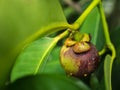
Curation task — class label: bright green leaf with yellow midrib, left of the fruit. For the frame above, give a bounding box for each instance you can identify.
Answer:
[11,37,57,81]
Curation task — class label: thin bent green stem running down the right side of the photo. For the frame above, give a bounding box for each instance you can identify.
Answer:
[99,2,116,90]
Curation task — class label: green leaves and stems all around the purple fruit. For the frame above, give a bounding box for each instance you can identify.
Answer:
[0,0,120,90]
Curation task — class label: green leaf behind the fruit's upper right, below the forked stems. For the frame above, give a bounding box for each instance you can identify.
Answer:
[80,7,104,50]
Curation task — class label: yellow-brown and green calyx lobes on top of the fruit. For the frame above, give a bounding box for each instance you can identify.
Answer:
[65,31,90,53]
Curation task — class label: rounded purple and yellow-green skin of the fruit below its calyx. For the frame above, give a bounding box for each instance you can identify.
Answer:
[60,43,99,77]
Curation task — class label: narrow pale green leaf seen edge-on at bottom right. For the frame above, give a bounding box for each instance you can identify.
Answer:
[104,55,112,90]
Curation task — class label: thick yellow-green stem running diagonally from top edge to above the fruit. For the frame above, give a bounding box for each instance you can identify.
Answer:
[73,0,101,30]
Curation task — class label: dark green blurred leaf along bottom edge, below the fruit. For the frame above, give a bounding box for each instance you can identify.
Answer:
[8,74,90,90]
